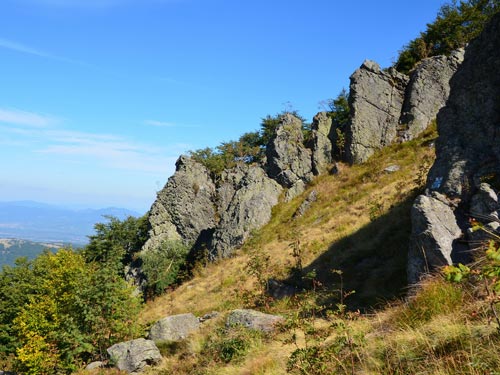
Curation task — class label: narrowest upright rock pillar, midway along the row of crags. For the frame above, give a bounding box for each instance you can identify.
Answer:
[311,112,336,175]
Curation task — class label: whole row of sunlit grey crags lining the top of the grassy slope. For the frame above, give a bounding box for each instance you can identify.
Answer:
[143,42,462,260]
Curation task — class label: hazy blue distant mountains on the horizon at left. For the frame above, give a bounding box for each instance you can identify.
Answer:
[0,201,140,245]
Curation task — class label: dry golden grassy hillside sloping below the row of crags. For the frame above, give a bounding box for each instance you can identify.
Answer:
[87,125,500,375]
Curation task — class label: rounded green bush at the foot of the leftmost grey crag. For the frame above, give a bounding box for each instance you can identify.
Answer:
[140,240,189,295]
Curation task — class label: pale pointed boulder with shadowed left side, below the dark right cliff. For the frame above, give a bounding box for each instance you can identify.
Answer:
[408,195,462,284]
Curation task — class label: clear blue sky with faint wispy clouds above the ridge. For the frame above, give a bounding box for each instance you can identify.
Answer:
[0,0,442,213]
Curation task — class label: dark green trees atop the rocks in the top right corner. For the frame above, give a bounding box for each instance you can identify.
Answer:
[395,0,500,74]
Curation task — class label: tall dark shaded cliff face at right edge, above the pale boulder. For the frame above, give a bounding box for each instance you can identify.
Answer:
[428,15,500,197]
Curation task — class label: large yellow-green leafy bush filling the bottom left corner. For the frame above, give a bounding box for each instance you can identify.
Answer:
[0,249,140,374]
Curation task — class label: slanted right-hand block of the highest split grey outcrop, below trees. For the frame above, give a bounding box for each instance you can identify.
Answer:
[398,49,464,141]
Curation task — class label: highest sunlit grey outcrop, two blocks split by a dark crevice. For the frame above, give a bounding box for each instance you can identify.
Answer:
[346,50,464,163]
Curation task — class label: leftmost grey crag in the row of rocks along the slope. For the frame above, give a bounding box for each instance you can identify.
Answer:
[144,156,216,250]
